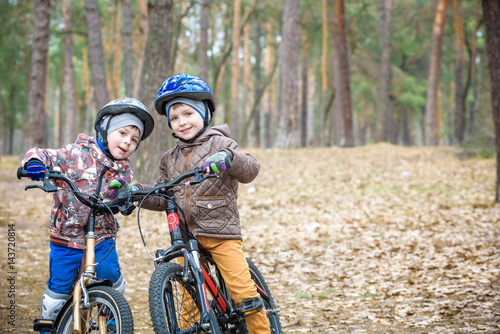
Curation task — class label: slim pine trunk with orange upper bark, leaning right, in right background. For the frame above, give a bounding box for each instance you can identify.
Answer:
[425,0,448,146]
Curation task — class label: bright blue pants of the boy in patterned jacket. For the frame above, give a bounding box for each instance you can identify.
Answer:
[47,239,121,294]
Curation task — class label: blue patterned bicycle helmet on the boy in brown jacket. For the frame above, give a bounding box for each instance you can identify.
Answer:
[155,73,215,127]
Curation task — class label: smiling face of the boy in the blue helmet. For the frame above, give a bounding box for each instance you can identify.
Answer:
[169,103,204,140]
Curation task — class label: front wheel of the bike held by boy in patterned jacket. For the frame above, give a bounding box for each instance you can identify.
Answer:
[56,286,134,334]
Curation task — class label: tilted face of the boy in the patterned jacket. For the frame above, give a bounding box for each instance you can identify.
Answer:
[107,125,141,160]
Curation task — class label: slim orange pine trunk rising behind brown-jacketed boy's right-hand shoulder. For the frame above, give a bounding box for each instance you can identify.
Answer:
[227,0,241,138]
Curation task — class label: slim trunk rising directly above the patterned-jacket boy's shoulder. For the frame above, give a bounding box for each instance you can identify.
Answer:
[63,0,77,142]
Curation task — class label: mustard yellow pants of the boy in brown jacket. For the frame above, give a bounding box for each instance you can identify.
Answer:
[178,237,270,334]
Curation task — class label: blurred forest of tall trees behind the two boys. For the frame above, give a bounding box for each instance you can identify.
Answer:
[0,0,498,175]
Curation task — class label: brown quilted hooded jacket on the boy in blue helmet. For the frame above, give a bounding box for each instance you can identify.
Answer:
[137,125,260,240]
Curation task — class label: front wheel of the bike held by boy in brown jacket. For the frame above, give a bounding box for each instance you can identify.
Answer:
[149,263,220,334]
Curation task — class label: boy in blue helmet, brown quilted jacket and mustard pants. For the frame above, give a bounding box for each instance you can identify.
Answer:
[119,74,269,334]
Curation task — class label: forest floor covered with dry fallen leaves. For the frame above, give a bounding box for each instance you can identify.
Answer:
[0,144,500,334]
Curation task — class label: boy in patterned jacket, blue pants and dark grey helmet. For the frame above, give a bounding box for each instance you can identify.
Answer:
[21,97,154,328]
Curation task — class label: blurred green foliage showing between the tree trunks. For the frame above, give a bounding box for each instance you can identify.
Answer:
[0,0,491,154]
